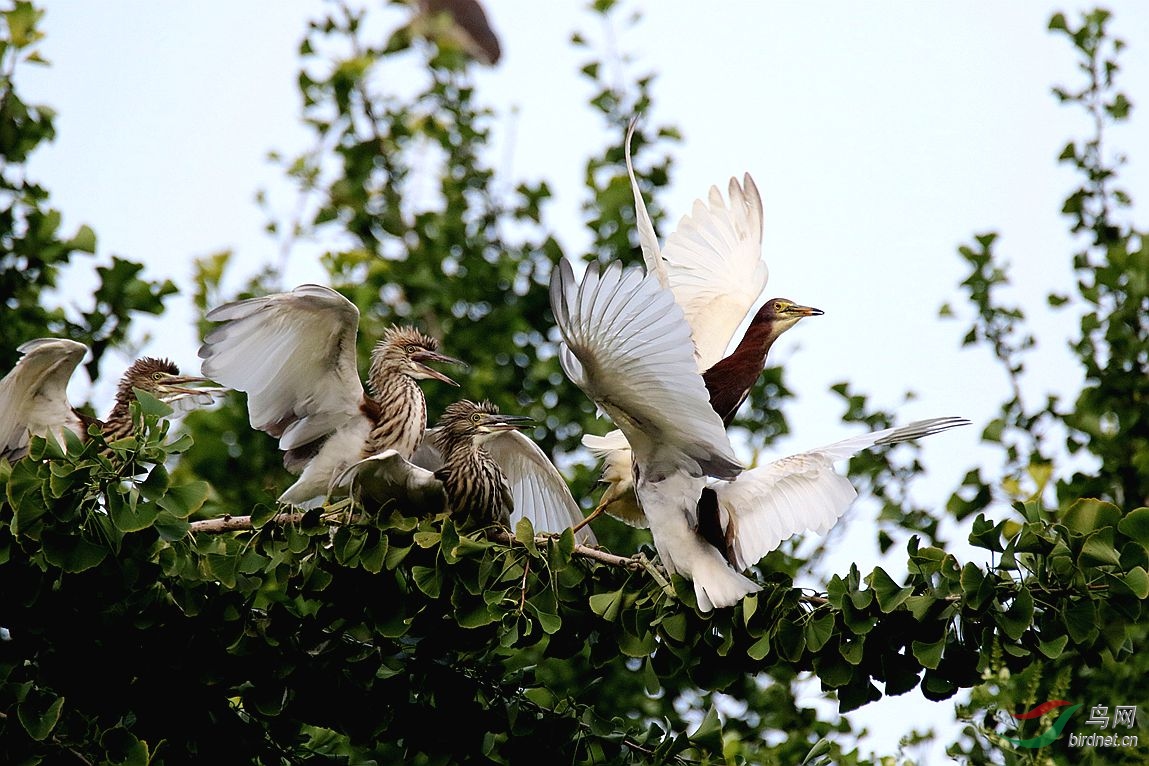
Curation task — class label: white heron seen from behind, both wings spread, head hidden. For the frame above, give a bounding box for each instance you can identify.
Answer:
[550,260,969,611]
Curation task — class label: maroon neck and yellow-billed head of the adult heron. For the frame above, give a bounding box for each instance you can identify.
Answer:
[702,297,823,426]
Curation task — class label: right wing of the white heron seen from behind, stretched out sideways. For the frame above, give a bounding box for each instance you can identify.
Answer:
[711,418,970,570]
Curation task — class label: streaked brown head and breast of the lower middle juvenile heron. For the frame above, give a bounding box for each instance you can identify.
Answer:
[433,399,531,527]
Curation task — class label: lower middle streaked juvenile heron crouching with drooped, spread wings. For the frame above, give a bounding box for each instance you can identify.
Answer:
[337,401,597,546]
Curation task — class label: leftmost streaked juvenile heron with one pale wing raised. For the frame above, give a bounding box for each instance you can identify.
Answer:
[0,338,225,461]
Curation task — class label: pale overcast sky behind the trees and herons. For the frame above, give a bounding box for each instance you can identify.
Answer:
[20,0,1149,763]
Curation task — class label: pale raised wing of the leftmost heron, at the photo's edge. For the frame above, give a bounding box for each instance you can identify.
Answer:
[0,338,87,458]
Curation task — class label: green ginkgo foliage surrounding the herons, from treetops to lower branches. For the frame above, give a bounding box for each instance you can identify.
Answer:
[0,2,1149,765]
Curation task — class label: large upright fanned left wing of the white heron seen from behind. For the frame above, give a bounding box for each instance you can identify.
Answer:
[550,260,742,478]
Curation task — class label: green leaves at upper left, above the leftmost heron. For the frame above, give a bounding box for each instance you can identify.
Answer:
[0,0,176,380]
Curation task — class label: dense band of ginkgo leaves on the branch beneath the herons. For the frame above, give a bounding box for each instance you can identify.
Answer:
[0,415,1149,764]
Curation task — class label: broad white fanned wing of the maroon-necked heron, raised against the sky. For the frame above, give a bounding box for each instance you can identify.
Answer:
[662,173,769,370]
